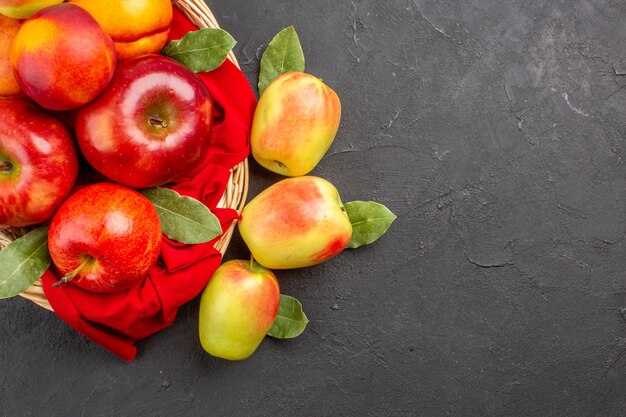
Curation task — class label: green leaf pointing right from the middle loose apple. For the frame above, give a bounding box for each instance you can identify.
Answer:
[344,201,396,248]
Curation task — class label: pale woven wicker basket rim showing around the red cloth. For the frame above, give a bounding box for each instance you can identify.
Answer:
[0,0,249,311]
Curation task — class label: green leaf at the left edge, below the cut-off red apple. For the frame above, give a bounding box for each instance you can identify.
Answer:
[0,227,51,298]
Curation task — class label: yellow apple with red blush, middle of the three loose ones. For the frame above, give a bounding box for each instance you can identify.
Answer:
[239,176,352,269]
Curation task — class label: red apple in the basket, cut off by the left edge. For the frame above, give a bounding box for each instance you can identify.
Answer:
[0,99,78,229]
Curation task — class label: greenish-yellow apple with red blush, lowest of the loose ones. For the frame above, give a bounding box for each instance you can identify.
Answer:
[199,260,280,360]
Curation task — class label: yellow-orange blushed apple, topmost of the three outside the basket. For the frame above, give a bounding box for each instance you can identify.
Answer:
[250,72,341,177]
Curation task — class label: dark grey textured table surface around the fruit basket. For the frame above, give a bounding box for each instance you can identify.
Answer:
[0,0,626,417]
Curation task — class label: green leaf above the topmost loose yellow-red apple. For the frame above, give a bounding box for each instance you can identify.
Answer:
[259,26,304,96]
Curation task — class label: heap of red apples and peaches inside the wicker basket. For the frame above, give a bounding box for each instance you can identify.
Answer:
[0,0,218,292]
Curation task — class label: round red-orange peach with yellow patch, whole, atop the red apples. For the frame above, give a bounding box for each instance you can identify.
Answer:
[10,3,116,110]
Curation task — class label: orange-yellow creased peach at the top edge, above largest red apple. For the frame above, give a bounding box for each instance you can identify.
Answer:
[70,0,173,60]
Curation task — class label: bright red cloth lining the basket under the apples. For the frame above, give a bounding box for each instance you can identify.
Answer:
[42,8,256,362]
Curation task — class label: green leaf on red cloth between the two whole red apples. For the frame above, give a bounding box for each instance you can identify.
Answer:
[141,187,222,244]
